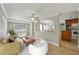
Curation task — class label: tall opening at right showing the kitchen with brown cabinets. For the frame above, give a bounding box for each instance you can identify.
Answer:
[59,11,79,50]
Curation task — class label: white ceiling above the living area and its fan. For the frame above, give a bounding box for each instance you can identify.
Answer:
[3,3,79,19]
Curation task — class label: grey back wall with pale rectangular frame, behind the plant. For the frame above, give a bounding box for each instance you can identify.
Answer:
[7,21,30,35]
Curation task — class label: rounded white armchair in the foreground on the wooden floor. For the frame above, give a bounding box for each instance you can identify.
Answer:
[29,39,48,55]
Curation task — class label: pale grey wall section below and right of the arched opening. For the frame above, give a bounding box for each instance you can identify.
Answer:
[35,16,60,45]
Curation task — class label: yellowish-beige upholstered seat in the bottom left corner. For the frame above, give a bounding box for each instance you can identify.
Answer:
[0,42,21,55]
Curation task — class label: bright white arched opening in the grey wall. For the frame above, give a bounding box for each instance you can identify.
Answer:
[36,19,55,31]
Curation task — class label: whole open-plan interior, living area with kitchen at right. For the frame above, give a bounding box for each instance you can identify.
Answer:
[0,3,79,55]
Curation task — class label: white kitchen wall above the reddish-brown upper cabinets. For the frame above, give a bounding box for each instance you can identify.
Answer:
[59,11,78,23]
